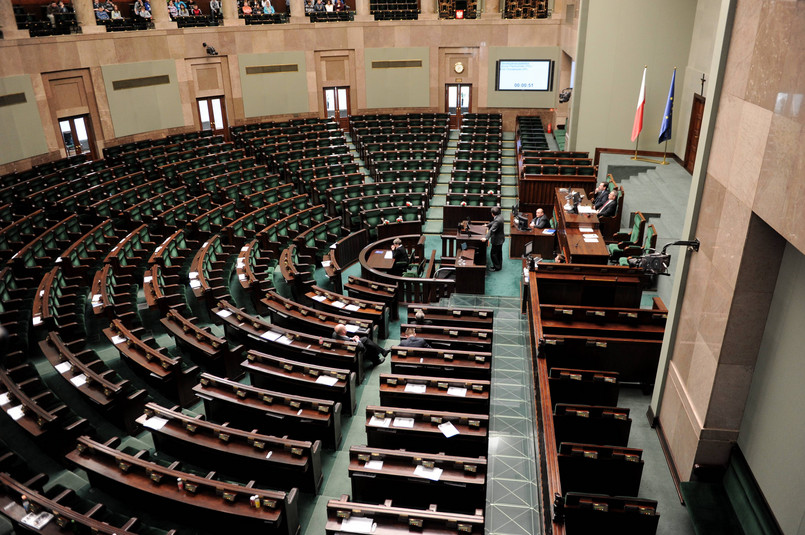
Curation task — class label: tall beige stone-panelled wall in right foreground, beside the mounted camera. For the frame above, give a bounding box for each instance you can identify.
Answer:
[659,0,805,480]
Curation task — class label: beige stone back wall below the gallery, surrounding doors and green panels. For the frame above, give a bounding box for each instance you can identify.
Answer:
[0,17,561,173]
